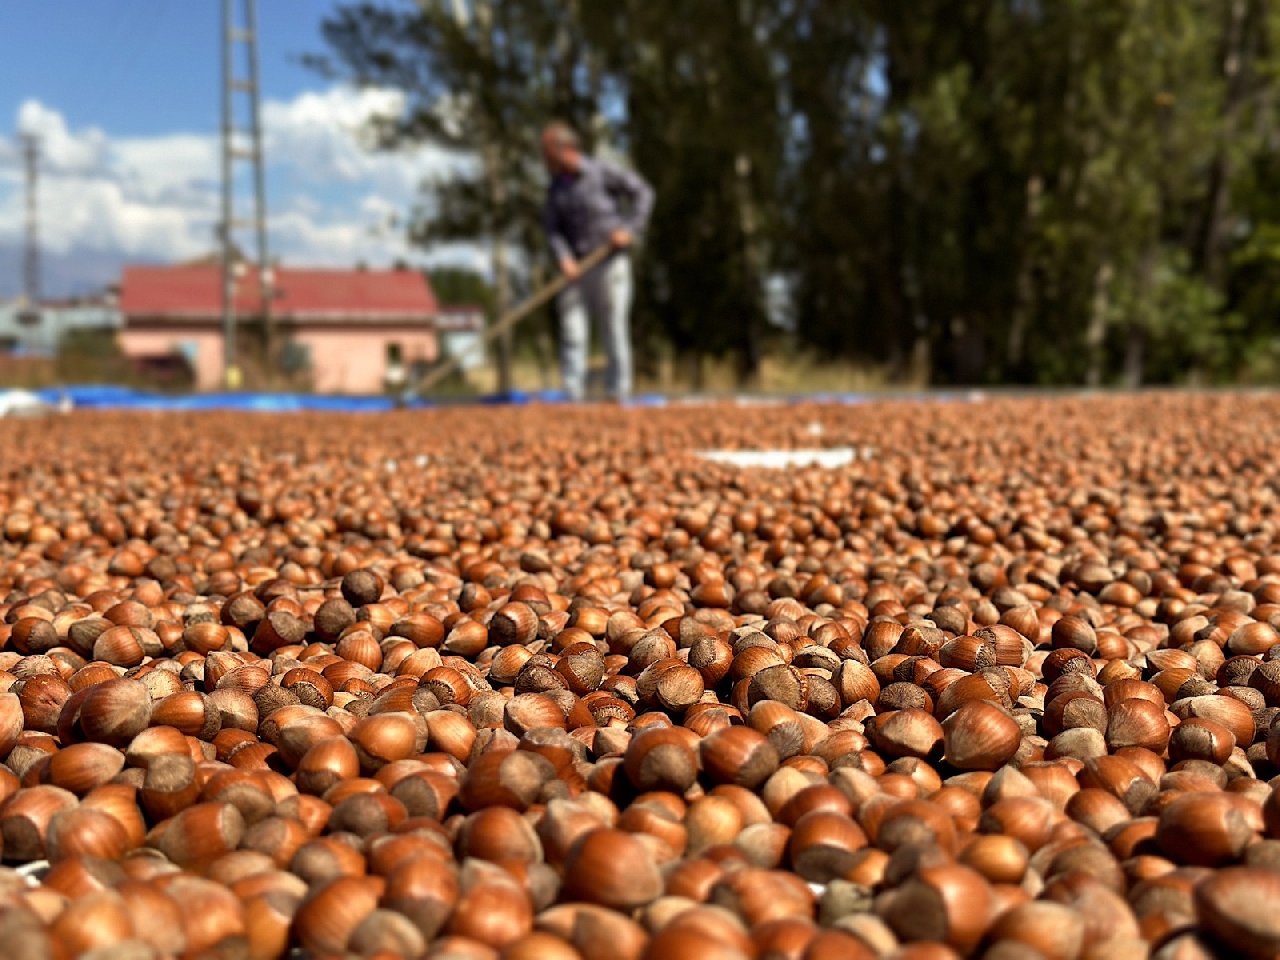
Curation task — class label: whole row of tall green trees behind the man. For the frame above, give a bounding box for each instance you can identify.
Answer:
[315,0,1280,385]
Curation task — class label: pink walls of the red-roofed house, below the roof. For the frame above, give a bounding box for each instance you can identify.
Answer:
[119,325,439,393]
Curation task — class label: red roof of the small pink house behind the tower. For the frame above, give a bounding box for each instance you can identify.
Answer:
[120,264,439,321]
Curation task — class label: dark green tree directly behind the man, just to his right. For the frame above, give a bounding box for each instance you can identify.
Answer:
[589,0,783,384]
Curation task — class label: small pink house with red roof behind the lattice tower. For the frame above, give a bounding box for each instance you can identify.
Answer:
[120,261,483,393]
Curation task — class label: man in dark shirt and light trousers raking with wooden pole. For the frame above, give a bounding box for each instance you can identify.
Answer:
[543,123,653,401]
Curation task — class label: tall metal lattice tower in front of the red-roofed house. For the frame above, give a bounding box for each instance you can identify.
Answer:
[220,0,274,388]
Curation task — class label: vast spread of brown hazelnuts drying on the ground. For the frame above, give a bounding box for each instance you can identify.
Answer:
[0,393,1280,960]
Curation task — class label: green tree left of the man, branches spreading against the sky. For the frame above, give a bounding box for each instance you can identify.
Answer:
[317,0,595,389]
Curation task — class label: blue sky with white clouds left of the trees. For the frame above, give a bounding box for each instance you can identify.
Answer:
[0,0,475,297]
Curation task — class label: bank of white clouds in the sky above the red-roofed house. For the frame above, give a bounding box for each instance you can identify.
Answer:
[0,87,481,288]
